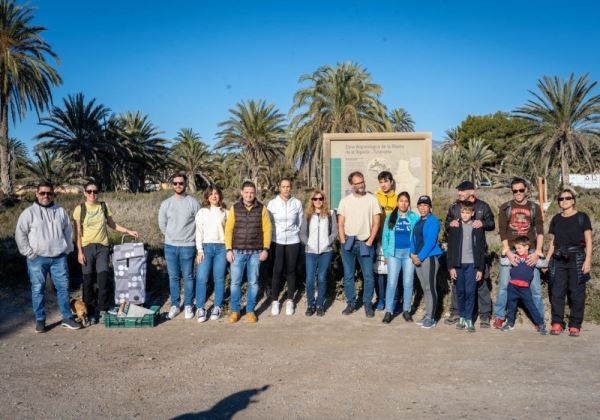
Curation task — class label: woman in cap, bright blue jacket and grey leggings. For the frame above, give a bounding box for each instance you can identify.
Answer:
[410,195,442,328]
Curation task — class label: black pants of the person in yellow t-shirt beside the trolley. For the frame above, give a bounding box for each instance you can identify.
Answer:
[82,244,111,313]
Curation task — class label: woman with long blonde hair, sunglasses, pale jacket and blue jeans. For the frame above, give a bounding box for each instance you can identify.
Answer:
[300,190,338,316]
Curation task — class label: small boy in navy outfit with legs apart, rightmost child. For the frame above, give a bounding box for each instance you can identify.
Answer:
[501,236,547,335]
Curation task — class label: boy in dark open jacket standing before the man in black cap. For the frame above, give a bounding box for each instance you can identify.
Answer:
[448,201,485,332]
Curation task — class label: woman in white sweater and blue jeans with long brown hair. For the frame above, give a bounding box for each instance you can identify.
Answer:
[196,185,227,322]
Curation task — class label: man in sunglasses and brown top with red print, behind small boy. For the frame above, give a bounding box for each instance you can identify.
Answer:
[494,178,544,329]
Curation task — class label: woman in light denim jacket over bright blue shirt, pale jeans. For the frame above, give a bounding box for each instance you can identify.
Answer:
[381,191,420,324]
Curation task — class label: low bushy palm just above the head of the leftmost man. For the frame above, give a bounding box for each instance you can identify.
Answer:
[25,150,81,187]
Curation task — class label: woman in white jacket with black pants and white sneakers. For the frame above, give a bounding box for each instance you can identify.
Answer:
[267,178,304,315]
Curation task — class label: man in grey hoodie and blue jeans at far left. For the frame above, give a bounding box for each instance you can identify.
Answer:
[15,182,81,333]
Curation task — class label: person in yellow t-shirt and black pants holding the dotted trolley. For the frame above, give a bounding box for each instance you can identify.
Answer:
[73,181,138,324]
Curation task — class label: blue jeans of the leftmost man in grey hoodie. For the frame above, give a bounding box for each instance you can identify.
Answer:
[27,254,73,321]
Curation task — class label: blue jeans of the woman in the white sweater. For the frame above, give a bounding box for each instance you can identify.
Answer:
[196,244,227,308]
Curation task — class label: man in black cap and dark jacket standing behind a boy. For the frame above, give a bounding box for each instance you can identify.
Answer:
[444,181,496,328]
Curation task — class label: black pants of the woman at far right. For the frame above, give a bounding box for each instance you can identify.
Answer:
[550,261,587,328]
